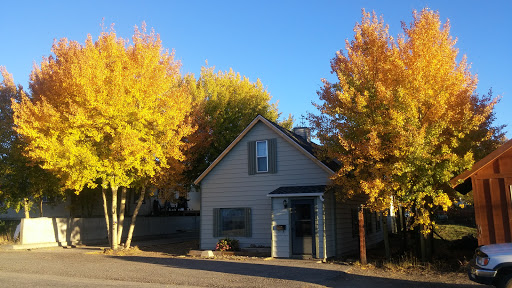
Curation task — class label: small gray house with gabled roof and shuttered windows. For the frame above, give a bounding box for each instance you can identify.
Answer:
[195,116,382,259]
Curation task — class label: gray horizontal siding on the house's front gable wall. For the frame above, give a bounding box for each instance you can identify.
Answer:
[200,122,329,249]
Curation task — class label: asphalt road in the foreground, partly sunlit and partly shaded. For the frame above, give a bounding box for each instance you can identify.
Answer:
[0,244,485,288]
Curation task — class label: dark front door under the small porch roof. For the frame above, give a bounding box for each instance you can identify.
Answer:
[291,199,315,256]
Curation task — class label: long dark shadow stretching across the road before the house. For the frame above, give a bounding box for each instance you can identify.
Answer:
[113,256,485,288]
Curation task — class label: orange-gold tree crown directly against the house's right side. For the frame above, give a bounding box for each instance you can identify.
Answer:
[310,11,405,214]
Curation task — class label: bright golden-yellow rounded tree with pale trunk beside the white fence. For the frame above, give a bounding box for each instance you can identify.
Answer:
[13,24,194,249]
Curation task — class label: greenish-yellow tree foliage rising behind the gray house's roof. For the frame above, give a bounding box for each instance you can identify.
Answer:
[177,67,293,183]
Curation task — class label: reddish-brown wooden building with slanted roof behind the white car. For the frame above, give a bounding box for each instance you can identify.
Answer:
[451,140,512,245]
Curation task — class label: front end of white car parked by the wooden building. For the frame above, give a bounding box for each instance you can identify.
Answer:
[468,243,512,288]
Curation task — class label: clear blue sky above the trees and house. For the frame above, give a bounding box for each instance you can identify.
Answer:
[0,0,512,138]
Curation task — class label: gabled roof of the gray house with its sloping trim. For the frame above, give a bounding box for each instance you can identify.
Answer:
[194,115,334,185]
